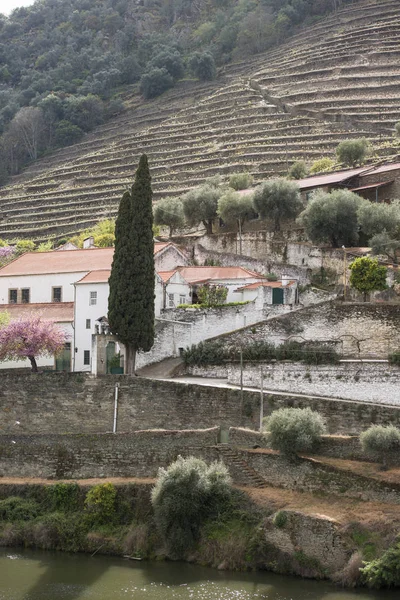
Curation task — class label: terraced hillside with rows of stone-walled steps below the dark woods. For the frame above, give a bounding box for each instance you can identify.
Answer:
[0,0,400,239]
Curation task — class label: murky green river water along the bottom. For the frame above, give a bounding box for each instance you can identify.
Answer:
[0,548,400,600]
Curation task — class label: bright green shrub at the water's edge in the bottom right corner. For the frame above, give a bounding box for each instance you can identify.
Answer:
[360,542,400,589]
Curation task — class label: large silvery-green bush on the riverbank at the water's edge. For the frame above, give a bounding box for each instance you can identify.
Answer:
[151,456,232,558]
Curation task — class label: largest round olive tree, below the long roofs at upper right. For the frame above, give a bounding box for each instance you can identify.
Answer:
[299,190,362,248]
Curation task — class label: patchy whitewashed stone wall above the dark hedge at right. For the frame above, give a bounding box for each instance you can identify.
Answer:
[209,301,400,358]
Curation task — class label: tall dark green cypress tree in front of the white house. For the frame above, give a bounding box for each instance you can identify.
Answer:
[108,155,155,375]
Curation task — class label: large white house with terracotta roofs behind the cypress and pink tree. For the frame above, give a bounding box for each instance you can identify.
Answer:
[0,242,188,371]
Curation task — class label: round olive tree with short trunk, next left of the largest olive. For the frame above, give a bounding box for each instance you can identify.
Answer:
[254,178,302,231]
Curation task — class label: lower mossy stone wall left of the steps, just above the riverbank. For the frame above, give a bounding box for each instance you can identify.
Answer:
[0,427,219,479]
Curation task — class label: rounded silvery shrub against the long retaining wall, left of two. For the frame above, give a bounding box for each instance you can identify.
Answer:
[264,408,325,456]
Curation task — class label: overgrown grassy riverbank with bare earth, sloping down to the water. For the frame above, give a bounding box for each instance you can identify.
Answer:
[0,478,400,586]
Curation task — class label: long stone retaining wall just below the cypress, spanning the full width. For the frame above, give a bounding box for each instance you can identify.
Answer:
[0,373,400,436]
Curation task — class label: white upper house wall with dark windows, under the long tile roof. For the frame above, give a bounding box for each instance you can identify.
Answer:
[0,271,87,304]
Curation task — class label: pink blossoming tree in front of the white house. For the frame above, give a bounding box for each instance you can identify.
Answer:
[0,315,68,373]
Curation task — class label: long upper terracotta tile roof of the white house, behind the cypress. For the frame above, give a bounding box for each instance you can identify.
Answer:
[0,242,174,277]
